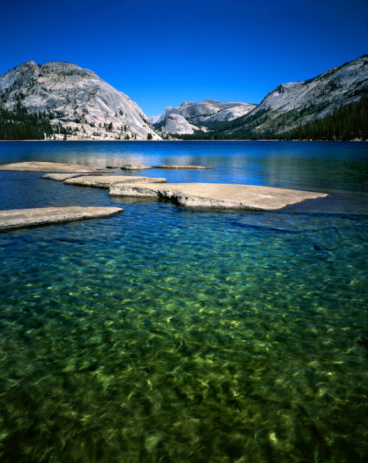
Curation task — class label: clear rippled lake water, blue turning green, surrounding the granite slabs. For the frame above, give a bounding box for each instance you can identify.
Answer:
[0,142,368,463]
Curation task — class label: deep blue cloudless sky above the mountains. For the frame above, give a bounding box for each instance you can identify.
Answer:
[0,0,368,116]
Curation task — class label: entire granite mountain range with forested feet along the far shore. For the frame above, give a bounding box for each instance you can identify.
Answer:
[0,55,368,140]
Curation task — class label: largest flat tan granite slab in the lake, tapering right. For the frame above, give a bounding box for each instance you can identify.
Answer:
[110,183,327,211]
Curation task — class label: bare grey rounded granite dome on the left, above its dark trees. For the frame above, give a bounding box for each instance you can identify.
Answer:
[0,61,160,140]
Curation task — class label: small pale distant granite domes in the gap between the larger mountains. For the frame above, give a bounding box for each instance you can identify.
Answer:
[156,99,256,134]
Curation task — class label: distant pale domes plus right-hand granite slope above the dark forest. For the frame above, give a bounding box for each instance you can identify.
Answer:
[154,55,368,138]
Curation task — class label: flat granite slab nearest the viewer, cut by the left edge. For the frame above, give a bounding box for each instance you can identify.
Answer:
[0,206,123,230]
